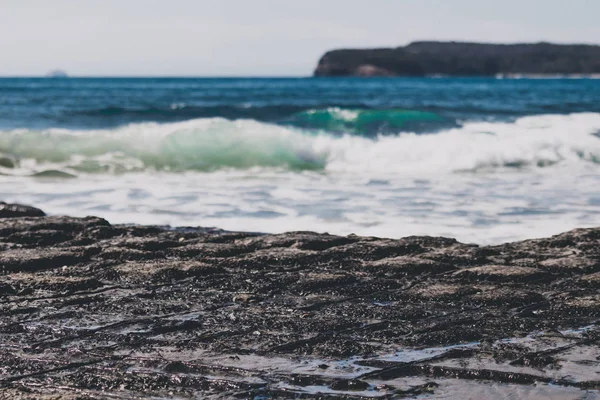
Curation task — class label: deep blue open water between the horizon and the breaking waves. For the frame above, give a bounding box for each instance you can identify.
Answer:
[0,78,600,130]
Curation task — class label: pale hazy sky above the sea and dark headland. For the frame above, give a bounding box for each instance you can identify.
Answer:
[0,0,600,76]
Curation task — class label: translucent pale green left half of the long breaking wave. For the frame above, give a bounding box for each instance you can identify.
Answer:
[0,118,327,173]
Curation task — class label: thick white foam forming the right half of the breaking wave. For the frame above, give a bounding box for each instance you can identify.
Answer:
[315,113,600,176]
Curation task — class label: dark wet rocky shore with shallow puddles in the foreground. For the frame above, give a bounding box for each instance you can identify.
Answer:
[0,204,600,399]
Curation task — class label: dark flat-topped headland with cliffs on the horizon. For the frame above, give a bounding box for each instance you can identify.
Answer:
[314,42,600,76]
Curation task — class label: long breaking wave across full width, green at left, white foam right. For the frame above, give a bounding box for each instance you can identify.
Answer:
[0,110,600,176]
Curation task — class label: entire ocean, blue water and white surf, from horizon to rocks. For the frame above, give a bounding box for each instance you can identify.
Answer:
[0,78,600,244]
